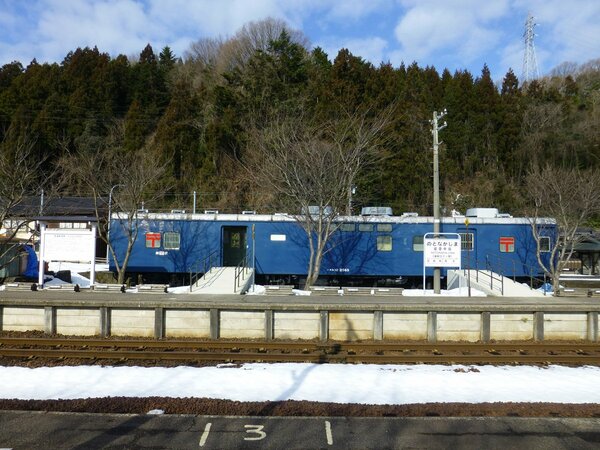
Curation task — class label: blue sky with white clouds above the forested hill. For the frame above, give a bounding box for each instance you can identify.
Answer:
[0,0,600,80]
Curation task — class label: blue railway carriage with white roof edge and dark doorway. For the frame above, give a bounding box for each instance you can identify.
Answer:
[110,208,556,286]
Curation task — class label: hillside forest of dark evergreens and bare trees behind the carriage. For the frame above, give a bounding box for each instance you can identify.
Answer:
[0,20,600,214]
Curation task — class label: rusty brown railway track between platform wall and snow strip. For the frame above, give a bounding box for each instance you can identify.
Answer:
[0,337,600,365]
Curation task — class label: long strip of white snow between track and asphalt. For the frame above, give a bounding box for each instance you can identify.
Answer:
[0,363,600,405]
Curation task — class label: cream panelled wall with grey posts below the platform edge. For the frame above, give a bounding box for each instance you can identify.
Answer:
[0,306,598,342]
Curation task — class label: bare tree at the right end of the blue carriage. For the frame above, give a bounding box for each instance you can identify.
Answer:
[525,166,600,293]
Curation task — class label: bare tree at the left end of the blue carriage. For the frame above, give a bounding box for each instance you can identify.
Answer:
[61,123,167,284]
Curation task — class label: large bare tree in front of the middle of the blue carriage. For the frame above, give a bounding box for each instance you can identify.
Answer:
[246,108,393,289]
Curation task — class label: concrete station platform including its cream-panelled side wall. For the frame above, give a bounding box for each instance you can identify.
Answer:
[0,291,600,342]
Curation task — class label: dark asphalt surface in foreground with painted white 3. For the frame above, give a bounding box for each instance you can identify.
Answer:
[0,411,600,450]
